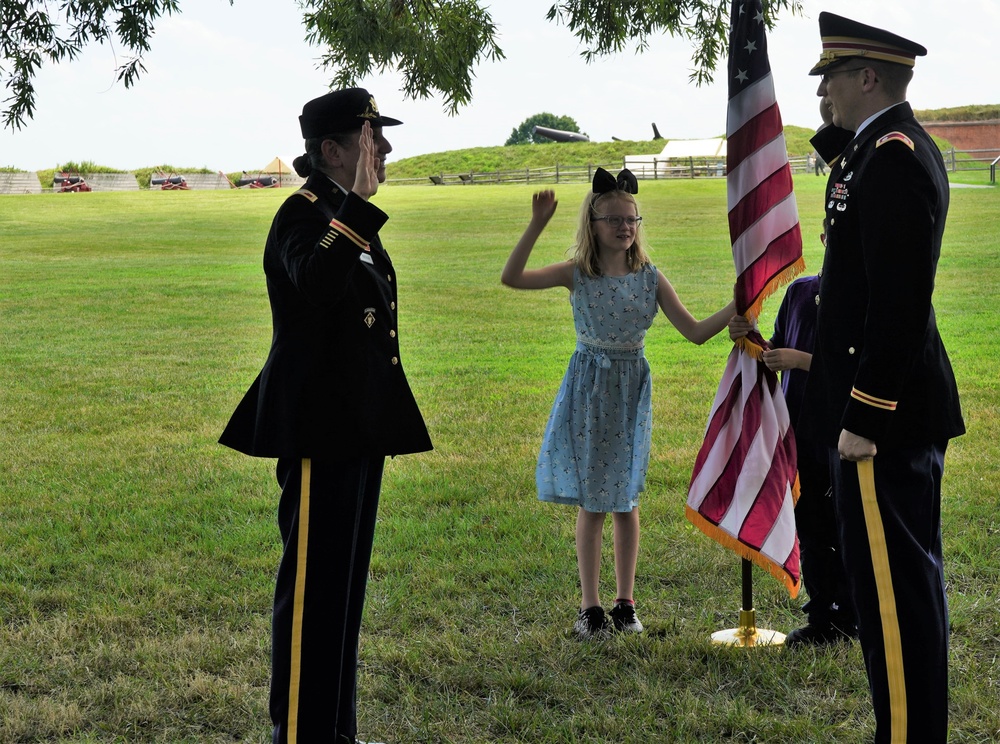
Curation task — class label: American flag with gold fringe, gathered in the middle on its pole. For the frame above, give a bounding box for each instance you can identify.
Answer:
[686,0,804,597]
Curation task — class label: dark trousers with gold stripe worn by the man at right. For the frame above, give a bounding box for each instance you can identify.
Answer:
[831,444,948,744]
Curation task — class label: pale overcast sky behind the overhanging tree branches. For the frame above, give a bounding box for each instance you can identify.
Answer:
[0,0,1000,172]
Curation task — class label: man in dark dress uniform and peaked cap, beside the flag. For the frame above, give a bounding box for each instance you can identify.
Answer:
[803,13,965,742]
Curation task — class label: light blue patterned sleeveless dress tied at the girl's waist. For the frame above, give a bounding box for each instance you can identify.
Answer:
[535,264,657,512]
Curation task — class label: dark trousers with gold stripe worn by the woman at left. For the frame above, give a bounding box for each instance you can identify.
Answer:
[270,456,385,744]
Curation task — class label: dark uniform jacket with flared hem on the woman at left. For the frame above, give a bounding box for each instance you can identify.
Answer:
[219,174,431,460]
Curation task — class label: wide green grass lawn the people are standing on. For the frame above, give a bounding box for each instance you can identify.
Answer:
[0,180,1000,744]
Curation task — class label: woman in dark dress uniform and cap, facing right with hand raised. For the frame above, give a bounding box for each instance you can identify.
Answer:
[220,88,431,744]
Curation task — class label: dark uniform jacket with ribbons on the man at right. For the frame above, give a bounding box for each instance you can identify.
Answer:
[803,103,965,448]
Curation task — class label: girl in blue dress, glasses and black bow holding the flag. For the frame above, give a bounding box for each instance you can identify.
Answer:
[501,168,735,638]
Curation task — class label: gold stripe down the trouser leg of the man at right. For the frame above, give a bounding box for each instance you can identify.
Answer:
[858,460,906,744]
